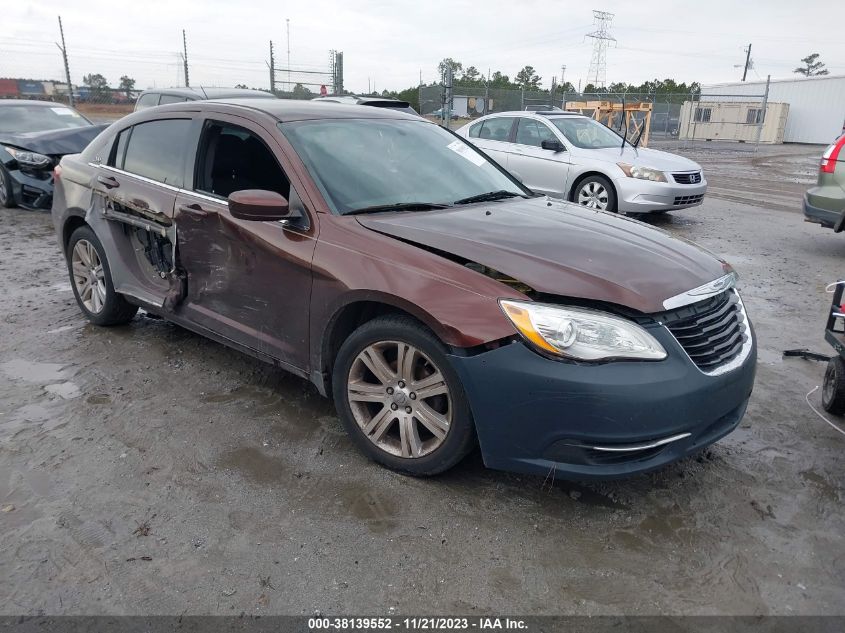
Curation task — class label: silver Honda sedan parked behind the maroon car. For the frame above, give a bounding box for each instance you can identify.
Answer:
[457,111,707,213]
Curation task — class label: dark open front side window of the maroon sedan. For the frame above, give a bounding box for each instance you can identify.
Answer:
[194,121,290,198]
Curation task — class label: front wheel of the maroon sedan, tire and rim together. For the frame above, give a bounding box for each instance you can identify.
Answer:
[332,315,475,476]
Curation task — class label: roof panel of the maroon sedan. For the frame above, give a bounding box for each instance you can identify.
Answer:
[170,99,420,122]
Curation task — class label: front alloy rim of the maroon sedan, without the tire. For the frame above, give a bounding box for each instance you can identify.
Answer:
[347,341,452,458]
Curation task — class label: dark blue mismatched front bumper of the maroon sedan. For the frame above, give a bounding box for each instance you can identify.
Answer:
[450,326,757,479]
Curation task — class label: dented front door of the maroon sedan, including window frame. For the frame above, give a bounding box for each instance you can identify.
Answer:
[175,114,316,370]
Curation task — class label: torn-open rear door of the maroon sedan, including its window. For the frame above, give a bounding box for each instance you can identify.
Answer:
[88,117,193,307]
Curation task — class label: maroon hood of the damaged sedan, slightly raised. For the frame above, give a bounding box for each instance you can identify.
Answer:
[357,198,731,313]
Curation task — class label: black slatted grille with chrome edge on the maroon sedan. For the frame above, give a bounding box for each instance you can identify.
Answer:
[661,290,748,370]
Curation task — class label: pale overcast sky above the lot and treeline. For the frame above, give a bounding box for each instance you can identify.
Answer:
[0,0,845,92]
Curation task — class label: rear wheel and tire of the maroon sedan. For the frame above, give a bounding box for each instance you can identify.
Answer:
[65,226,138,326]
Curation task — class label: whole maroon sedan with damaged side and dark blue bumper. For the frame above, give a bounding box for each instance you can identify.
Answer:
[53,100,756,478]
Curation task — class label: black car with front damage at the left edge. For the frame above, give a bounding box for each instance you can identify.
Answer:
[0,99,107,210]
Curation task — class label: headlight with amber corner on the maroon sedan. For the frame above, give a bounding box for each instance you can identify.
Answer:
[499,299,666,360]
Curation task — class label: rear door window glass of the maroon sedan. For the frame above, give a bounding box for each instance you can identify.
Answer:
[123,119,191,187]
